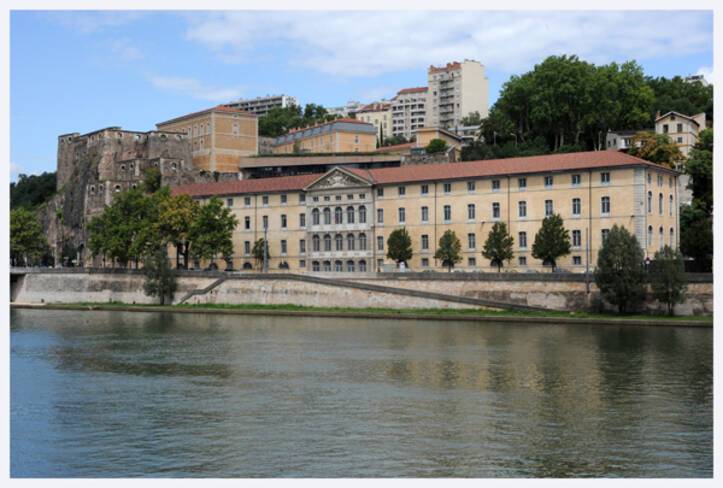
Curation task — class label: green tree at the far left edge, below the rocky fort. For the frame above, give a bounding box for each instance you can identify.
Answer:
[10,207,48,266]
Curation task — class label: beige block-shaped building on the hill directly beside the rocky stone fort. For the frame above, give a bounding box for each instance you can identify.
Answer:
[156,105,259,173]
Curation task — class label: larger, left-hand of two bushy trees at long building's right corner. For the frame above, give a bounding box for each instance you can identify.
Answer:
[595,225,645,313]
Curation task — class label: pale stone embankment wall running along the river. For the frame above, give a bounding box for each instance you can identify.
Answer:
[11,269,713,315]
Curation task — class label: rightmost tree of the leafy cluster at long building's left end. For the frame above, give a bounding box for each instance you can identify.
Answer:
[189,197,238,266]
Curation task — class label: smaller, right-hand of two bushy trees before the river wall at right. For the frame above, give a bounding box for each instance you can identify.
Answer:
[649,246,687,315]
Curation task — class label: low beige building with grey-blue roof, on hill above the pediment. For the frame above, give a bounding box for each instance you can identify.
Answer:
[273,119,377,154]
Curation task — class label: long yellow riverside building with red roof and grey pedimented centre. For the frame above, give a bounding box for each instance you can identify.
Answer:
[174,151,679,272]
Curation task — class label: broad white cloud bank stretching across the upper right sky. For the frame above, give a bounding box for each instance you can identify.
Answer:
[185,11,712,76]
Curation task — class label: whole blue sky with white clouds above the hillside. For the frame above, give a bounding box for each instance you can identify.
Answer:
[10,11,713,180]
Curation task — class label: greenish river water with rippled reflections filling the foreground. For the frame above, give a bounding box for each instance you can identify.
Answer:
[11,310,713,477]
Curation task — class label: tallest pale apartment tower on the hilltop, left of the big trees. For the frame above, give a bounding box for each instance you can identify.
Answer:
[426,59,489,129]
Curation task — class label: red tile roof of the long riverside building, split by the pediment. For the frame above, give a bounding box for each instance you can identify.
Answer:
[173,151,675,196]
